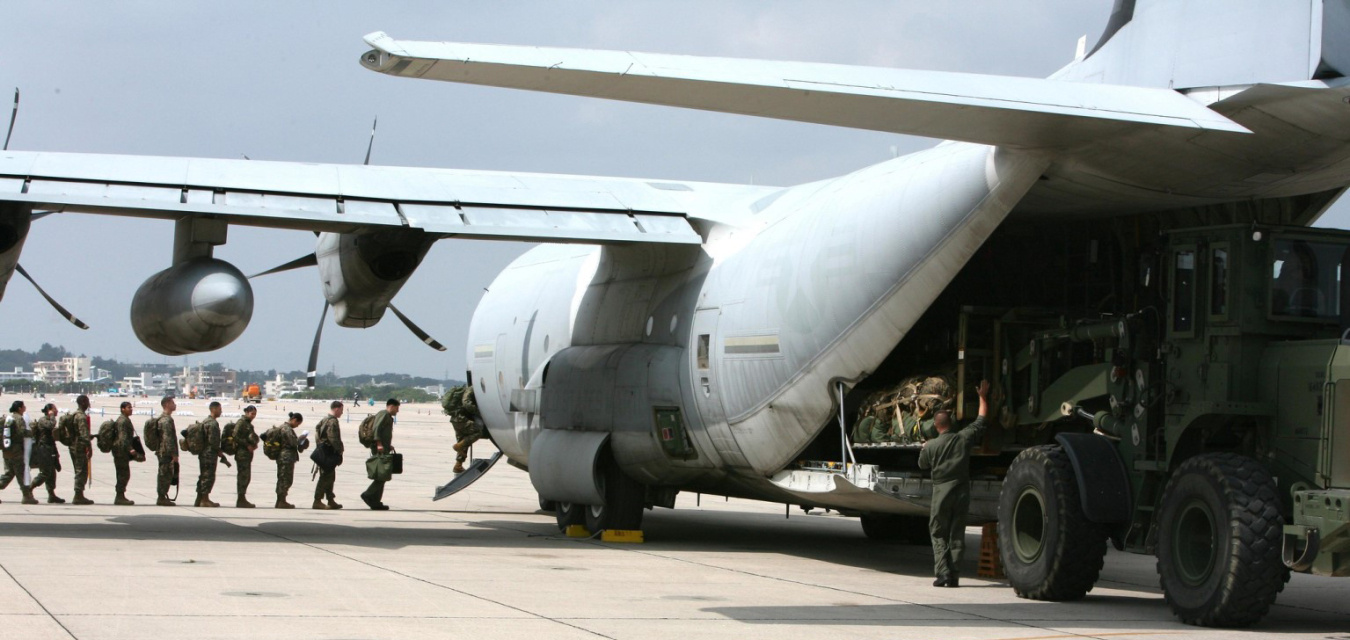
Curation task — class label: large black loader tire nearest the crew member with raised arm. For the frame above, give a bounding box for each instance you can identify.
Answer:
[999,444,1107,601]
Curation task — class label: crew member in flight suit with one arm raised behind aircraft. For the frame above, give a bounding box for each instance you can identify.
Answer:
[919,381,990,587]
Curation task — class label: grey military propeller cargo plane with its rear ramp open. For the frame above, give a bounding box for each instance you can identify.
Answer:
[0,0,1350,626]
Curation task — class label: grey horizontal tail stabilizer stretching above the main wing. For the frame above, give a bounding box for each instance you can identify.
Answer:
[360,32,1250,149]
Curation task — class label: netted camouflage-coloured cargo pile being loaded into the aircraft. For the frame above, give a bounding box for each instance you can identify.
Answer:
[851,375,956,446]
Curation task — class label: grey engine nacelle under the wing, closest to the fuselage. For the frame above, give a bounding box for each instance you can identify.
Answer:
[315,228,436,328]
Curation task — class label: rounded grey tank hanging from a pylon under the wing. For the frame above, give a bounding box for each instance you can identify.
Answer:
[131,258,252,355]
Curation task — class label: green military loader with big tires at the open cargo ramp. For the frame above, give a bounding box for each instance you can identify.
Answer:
[836,224,1350,626]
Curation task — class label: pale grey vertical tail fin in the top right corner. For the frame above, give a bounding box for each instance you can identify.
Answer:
[1054,0,1350,90]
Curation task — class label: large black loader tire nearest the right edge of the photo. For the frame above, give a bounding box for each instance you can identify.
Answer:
[1157,454,1285,626]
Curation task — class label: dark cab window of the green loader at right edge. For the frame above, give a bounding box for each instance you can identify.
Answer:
[1270,238,1346,320]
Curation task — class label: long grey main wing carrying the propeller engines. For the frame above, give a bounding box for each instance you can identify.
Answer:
[0,151,776,244]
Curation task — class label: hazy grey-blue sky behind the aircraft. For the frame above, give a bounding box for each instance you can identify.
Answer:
[0,0,1350,377]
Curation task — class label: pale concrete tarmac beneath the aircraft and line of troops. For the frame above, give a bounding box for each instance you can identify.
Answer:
[0,396,1350,640]
